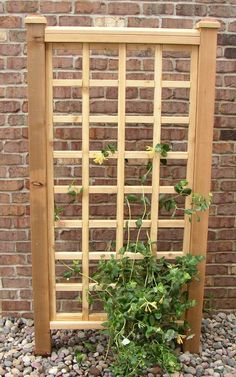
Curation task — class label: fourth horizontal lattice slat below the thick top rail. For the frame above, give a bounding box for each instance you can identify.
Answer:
[54,185,175,194]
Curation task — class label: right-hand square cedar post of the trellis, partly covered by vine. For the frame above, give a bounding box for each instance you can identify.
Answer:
[185,20,220,353]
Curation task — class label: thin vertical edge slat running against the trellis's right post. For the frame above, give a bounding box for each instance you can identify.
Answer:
[183,46,198,254]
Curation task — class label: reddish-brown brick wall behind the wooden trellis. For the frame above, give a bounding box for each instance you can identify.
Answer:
[0,0,236,316]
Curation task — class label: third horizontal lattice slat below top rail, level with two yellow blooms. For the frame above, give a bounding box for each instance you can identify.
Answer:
[53,151,188,160]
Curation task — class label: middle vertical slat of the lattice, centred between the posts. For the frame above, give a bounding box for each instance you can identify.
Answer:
[116,44,126,253]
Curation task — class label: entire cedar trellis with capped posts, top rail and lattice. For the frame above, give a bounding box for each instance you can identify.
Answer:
[26,16,219,354]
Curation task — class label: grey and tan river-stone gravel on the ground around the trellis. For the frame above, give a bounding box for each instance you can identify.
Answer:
[0,313,236,377]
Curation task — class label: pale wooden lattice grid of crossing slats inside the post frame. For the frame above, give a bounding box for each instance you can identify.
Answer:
[47,43,198,328]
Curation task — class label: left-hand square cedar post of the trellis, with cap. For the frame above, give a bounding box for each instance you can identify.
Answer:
[25,15,51,355]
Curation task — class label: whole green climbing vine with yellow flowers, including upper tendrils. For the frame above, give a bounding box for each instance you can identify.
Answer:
[60,144,212,377]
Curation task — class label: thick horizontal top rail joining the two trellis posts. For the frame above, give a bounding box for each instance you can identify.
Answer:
[45,26,200,45]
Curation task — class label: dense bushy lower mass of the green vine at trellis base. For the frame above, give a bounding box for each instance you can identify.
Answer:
[93,248,202,377]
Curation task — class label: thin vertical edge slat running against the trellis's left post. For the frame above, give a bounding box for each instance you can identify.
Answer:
[46,43,56,321]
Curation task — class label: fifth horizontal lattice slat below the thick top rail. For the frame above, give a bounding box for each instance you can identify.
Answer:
[55,219,184,228]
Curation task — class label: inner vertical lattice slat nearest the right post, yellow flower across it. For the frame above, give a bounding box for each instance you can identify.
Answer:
[150,45,162,253]
